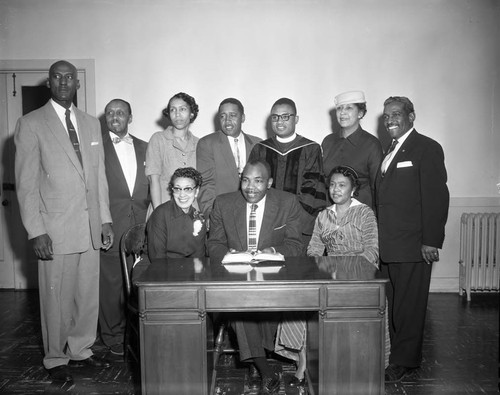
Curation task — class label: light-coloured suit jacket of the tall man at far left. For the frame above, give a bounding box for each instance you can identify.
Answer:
[14,101,112,254]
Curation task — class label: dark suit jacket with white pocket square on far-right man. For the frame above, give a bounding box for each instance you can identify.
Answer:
[375,130,450,262]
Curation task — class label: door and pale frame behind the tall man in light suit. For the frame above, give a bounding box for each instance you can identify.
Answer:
[0,67,87,289]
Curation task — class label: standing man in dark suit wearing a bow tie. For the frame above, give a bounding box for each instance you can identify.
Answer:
[99,99,150,355]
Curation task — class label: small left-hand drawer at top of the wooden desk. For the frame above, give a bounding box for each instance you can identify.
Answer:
[144,288,199,310]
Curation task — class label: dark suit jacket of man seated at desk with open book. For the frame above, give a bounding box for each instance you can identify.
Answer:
[208,188,305,262]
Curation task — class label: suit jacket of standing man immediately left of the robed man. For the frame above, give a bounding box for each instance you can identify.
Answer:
[196,131,261,218]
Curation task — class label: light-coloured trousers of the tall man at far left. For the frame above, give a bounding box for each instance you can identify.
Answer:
[38,247,99,369]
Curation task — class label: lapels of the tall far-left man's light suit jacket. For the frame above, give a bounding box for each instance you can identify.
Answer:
[45,101,88,179]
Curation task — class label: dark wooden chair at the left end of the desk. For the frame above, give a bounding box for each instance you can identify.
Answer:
[120,223,149,361]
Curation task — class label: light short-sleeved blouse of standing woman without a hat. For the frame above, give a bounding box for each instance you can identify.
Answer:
[146,126,199,203]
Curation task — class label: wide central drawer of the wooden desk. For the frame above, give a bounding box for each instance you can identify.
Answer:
[205,286,320,311]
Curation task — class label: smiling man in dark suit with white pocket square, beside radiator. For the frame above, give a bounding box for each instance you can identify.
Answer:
[375,96,449,382]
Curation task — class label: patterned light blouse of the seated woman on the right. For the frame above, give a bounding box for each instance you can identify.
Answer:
[307,199,379,267]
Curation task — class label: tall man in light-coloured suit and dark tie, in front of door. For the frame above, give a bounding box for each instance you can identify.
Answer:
[14,61,114,382]
